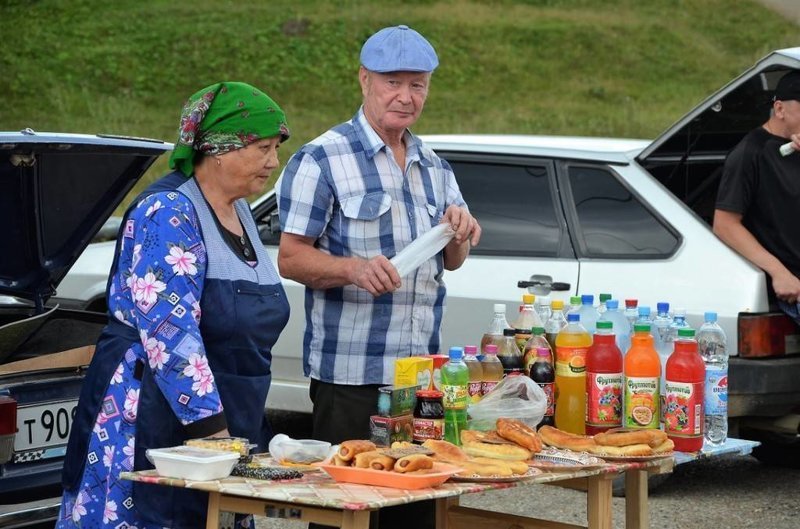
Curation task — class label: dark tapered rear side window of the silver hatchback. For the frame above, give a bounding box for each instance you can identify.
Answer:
[567,165,680,259]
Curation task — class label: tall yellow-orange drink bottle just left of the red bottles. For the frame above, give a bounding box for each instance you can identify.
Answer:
[556,312,592,435]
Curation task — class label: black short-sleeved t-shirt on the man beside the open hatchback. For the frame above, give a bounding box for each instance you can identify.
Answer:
[716,127,800,282]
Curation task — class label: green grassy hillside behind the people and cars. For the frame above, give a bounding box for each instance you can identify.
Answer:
[0,0,800,200]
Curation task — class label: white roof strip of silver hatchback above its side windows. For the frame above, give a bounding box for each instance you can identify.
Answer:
[420,134,650,163]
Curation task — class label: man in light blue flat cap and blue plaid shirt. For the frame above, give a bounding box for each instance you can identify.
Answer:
[276,22,481,448]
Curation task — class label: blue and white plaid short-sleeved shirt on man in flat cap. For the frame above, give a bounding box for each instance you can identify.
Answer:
[275,109,465,385]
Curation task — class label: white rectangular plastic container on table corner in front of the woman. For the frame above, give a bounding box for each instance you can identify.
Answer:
[146,446,239,481]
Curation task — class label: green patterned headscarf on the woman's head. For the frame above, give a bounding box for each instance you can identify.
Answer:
[169,82,289,176]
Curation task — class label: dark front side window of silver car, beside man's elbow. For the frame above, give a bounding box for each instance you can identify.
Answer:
[445,155,572,257]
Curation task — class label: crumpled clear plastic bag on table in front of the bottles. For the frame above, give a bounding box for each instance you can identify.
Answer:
[469,376,547,431]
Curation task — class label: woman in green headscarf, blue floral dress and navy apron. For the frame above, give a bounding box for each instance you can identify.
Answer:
[57,82,289,529]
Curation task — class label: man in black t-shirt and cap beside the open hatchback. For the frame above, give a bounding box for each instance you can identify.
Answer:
[714,70,800,323]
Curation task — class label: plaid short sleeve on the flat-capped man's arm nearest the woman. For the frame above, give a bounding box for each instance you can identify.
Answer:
[275,148,334,239]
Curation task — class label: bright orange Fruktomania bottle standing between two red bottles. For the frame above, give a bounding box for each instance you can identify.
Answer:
[622,323,661,429]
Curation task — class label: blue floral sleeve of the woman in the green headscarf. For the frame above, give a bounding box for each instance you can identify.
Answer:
[124,192,226,437]
